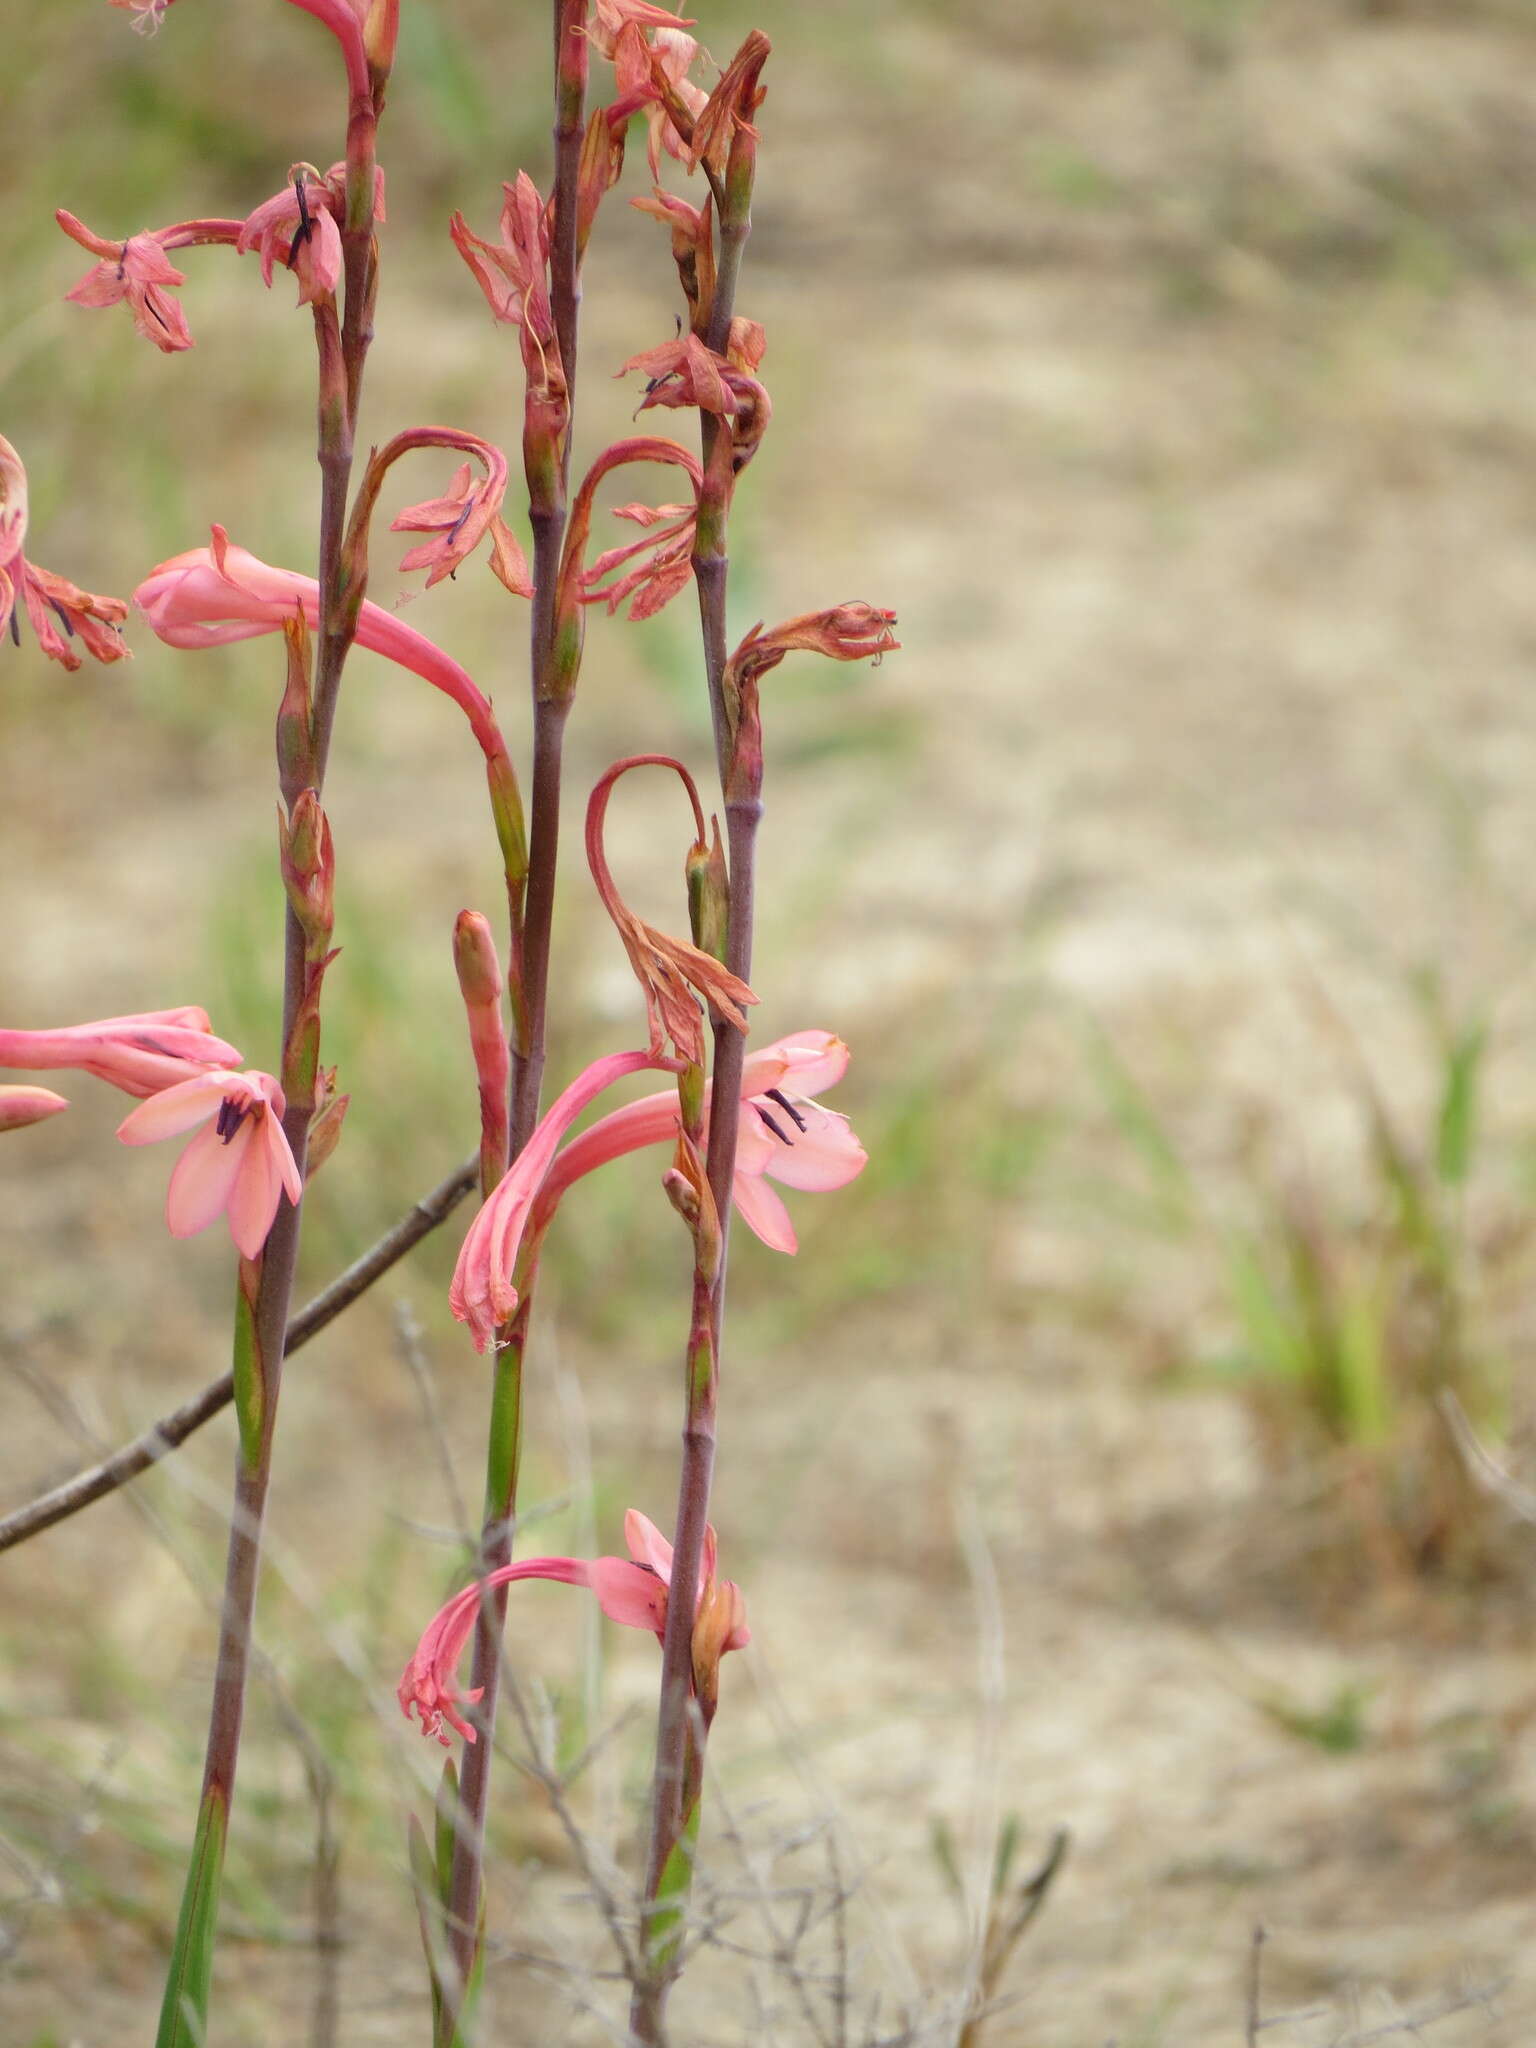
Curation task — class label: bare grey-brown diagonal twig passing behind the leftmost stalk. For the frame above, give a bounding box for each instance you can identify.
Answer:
[0,1159,475,1550]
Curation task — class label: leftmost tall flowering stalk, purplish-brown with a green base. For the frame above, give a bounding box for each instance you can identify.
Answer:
[156,0,393,2048]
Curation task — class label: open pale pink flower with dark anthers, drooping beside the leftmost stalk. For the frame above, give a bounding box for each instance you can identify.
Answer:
[117,1067,303,1260]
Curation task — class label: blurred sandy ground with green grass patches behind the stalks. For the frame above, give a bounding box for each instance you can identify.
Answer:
[0,0,1536,2048]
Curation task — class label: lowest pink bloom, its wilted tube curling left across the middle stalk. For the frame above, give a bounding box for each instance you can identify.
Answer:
[399,1507,752,1749]
